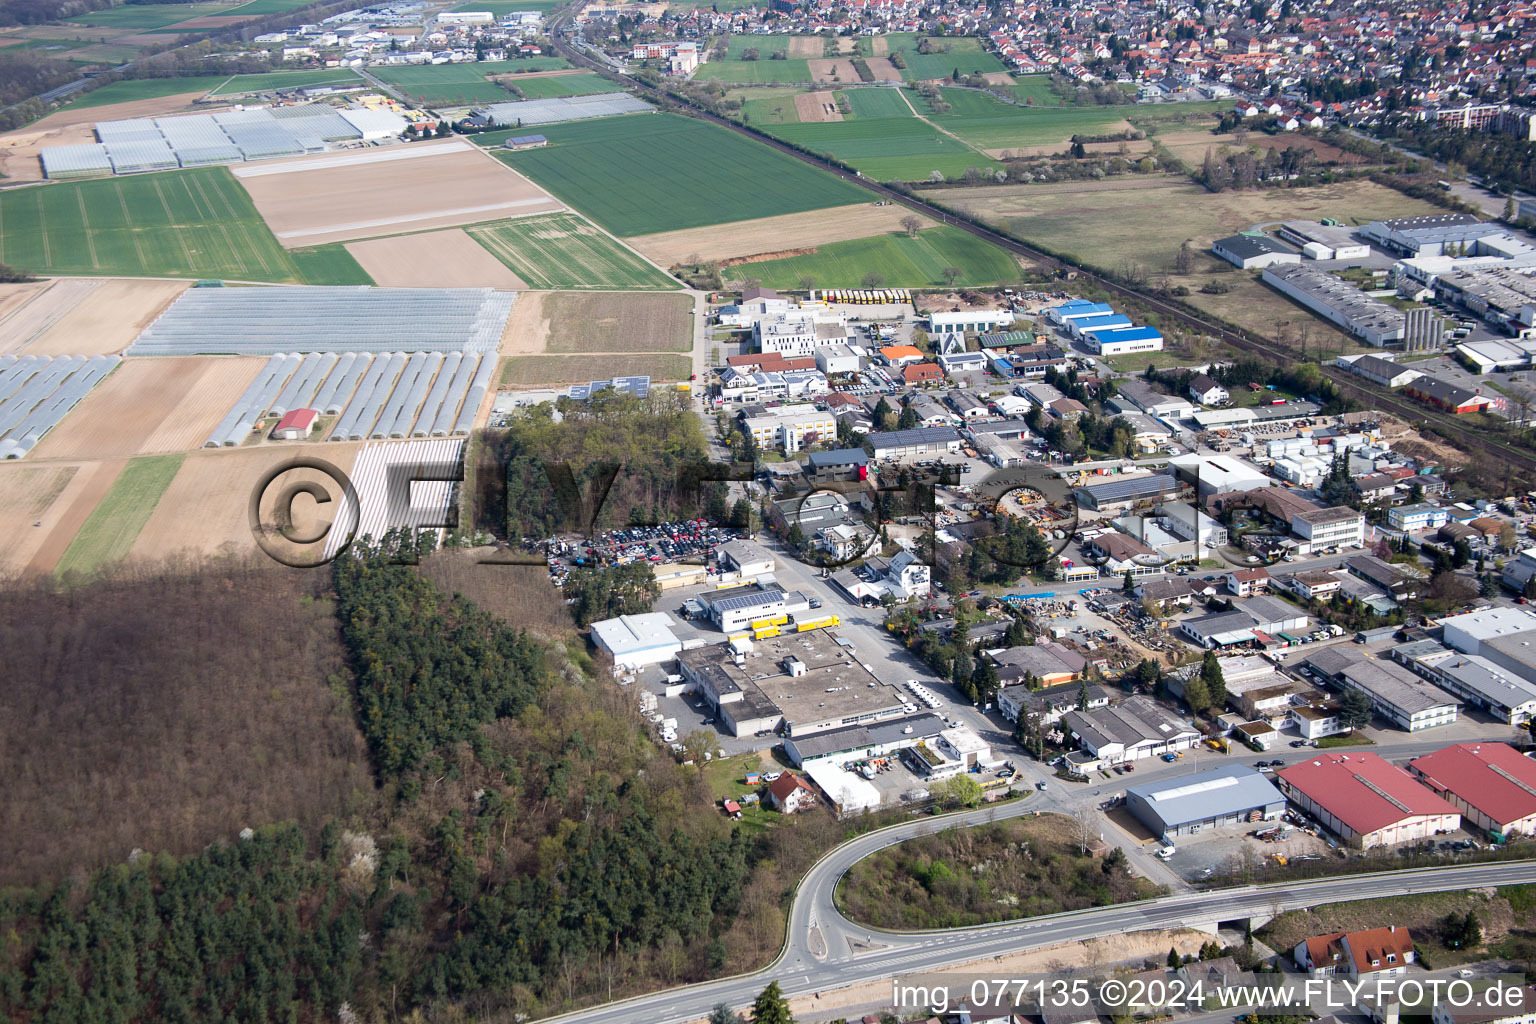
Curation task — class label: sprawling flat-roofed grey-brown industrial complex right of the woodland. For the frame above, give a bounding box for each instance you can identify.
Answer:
[677,629,906,738]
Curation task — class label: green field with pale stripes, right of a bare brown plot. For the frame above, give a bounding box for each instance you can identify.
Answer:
[467,213,679,289]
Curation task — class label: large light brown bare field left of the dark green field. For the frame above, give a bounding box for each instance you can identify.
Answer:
[230,141,565,247]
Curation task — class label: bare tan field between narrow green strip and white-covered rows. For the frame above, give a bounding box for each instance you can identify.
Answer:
[129,441,364,560]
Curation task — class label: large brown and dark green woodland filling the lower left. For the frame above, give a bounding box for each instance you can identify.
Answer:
[0,540,817,1022]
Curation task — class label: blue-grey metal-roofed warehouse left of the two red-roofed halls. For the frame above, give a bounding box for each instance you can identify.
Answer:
[1126,765,1286,841]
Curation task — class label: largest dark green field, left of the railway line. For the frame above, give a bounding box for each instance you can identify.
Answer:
[476,114,869,235]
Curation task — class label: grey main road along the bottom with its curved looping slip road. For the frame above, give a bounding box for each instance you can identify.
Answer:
[547,800,1536,1024]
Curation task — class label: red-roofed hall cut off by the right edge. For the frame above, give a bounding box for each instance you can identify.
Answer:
[1409,743,1536,835]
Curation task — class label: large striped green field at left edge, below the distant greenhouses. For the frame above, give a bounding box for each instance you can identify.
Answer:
[0,167,311,282]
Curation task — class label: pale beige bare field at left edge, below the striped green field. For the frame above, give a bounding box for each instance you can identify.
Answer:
[0,278,187,356]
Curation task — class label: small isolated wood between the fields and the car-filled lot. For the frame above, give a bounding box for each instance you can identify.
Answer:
[468,391,707,542]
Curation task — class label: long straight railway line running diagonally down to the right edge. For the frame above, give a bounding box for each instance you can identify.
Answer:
[551,28,1536,473]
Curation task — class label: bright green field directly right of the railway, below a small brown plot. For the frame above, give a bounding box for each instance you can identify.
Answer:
[763,115,1001,181]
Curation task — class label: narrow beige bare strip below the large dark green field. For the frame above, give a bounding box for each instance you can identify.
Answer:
[626,203,932,267]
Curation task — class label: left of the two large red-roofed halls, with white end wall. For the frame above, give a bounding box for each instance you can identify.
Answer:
[1275,754,1461,849]
